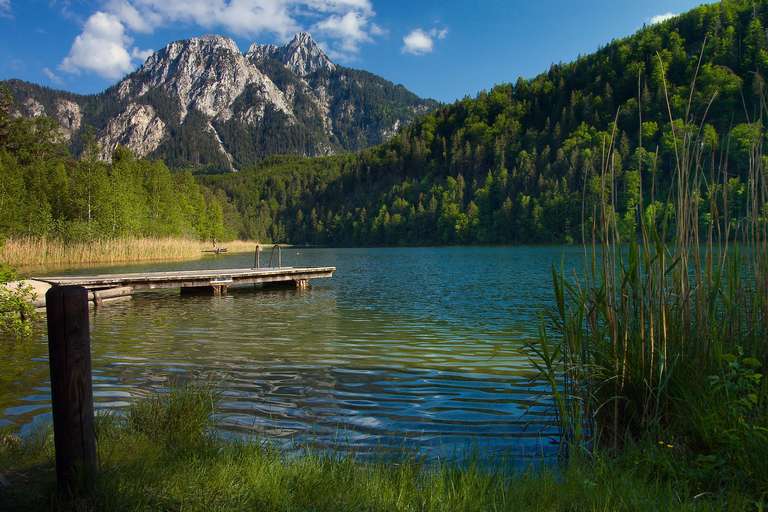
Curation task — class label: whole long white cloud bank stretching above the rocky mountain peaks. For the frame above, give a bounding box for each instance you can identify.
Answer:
[59,0,385,79]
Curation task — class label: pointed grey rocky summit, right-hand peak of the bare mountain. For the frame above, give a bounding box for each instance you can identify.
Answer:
[247,32,336,77]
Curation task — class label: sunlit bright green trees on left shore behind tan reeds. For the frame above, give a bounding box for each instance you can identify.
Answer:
[0,91,237,242]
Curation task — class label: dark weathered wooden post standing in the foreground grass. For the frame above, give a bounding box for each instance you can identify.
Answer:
[45,286,96,495]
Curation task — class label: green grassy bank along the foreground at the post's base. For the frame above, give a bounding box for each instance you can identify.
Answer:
[0,389,752,512]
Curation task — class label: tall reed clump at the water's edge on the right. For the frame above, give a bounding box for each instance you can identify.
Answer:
[529,50,768,505]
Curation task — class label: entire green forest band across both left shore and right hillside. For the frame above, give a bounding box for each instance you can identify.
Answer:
[0,0,768,245]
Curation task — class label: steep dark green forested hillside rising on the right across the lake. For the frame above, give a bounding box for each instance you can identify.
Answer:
[206,0,768,245]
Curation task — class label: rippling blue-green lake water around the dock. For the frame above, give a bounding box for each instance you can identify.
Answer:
[0,247,582,461]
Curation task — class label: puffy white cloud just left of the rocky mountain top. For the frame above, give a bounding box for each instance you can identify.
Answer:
[59,11,152,79]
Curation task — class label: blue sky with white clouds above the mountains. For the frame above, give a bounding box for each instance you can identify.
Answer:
[0,0,702,102]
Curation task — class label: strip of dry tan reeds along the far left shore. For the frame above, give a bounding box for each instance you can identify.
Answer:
[0,237,256,267]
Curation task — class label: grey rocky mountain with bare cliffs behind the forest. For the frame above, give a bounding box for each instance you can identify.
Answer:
[5,32,438,171]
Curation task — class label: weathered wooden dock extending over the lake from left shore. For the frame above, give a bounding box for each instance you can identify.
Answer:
[34,267,336,297]
